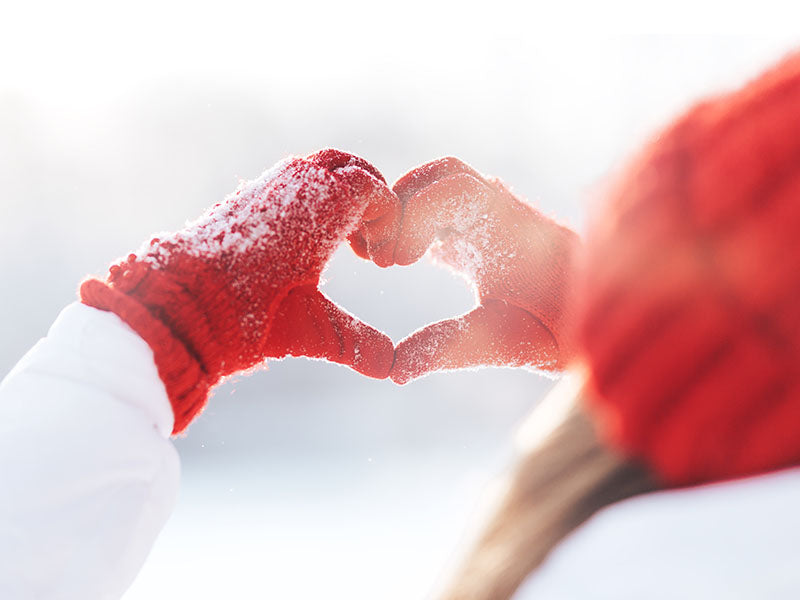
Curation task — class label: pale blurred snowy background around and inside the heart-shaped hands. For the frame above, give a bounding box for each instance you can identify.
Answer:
[0,2,798,600]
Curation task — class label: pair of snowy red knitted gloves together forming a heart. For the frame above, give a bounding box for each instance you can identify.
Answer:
[81,150,577,433]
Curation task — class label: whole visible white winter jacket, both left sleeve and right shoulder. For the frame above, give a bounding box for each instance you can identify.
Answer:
[0,304,800,600]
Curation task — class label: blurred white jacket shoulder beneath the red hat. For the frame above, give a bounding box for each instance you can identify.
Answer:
[514,469,800,600]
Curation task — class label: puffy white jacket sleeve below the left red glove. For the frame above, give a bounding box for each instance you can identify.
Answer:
[0,304,179,600]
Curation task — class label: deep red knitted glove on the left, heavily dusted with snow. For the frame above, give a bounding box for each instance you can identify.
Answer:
[80,150,400,433]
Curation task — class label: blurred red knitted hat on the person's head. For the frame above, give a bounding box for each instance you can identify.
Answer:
[577,49,800,485]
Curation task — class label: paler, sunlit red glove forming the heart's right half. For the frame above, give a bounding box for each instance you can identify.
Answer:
[390,158,578,384]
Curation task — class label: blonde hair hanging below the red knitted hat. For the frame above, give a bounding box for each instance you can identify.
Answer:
[442,381,659,600]
